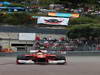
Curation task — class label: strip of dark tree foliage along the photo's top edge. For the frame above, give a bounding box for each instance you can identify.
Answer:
[0,0,100,8]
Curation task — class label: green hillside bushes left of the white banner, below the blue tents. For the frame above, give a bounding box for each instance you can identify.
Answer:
[0,12,33,25]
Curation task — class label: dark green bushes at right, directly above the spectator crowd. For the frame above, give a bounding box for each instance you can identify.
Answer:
[67,24,100,39]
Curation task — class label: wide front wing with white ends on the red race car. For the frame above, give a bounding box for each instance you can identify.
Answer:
[16,56,66,64]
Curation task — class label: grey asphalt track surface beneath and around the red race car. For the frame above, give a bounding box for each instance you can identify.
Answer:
[0,56,100,75]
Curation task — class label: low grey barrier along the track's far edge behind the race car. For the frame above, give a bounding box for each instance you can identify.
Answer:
[0,51,100,57]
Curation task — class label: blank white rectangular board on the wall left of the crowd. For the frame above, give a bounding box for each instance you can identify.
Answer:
[19,33,36,40]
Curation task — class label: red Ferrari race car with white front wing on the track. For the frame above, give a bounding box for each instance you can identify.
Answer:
[16,50,66,65]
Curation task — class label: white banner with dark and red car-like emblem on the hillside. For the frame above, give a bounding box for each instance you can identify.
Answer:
[37,17,69,25]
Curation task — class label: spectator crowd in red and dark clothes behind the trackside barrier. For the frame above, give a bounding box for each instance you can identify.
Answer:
[36,36,100,51]
